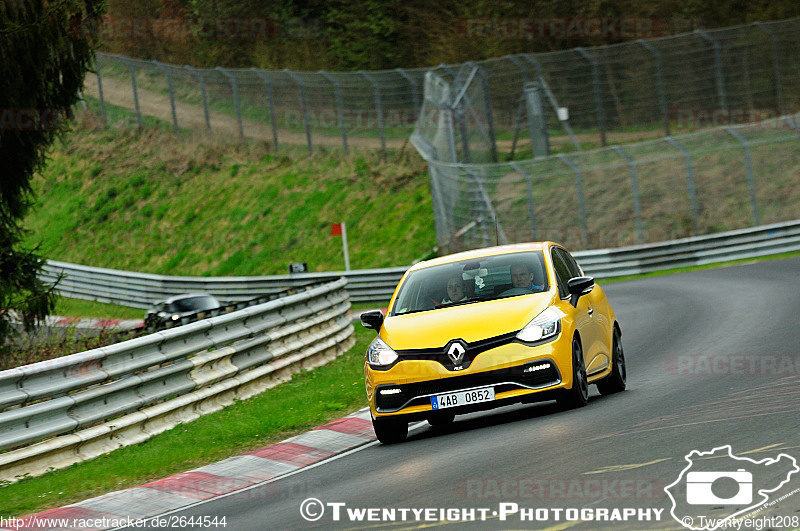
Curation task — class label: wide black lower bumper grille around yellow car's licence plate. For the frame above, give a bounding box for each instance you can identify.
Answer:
[375,360,560,411]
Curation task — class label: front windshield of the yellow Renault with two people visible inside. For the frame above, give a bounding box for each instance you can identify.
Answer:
[390,251,548,315]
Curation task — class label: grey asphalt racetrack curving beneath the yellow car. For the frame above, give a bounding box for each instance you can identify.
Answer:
[131,258,800,529]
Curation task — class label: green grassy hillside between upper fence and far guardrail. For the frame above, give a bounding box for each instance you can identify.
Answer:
[26,126,435,275]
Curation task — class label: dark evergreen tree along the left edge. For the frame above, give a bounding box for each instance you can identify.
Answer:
[0,0,105,346]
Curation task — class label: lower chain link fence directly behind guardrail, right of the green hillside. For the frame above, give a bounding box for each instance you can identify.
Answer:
[415,113,800,252]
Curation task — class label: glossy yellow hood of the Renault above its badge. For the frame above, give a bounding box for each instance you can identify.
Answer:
[381,292,553,350]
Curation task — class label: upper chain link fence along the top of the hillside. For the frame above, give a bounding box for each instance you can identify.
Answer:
[84,19,800,158]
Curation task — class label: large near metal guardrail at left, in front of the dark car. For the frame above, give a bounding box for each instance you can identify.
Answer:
[0,278,354,482]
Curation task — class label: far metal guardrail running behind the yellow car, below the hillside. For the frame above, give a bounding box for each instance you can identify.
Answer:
[43,220,800,308]
